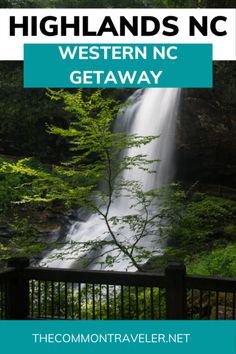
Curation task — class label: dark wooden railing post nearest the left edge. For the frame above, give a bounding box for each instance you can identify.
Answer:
[7,257,29,320]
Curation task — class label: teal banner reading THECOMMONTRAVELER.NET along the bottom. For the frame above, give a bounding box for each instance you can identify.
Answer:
[0,320,236,354]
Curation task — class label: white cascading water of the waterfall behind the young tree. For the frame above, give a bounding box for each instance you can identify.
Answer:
[41,88,180,270]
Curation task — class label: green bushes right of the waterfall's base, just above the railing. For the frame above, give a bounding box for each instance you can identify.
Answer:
[145,184,236,277]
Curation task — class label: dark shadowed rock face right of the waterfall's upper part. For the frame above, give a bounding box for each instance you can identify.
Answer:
[176,62,236,186]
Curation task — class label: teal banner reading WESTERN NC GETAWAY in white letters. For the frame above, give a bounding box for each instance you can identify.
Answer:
[24,44,212,88]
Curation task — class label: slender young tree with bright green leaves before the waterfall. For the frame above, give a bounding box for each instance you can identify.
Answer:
[0,90,162,270]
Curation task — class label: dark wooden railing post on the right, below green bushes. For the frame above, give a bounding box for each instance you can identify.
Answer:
[165,263,187,320]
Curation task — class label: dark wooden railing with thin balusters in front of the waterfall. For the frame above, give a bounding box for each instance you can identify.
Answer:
[0,258,236,320]
